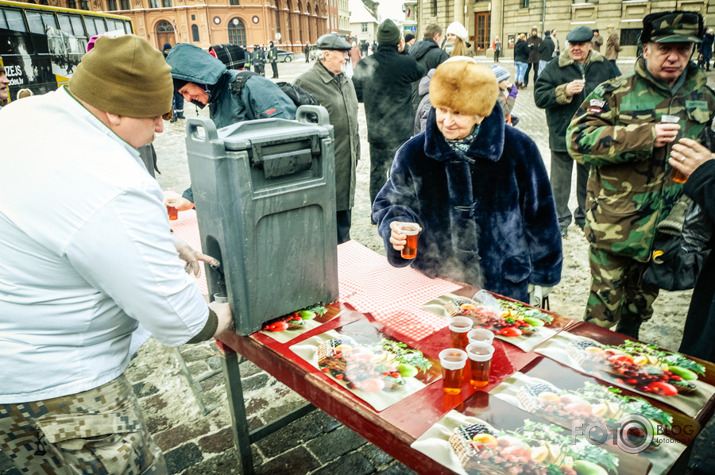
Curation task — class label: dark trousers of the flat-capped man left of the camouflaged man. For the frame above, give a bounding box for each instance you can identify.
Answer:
[551,150,589,231]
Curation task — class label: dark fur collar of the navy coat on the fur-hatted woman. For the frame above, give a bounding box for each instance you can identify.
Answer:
[424,104,506,162]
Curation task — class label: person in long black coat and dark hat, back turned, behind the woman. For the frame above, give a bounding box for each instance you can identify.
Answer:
[352,20,424,218]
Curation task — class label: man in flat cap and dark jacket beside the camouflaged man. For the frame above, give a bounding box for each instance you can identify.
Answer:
[534,26,618,236]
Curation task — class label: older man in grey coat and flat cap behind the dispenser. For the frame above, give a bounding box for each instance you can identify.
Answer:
[295,33,360,244]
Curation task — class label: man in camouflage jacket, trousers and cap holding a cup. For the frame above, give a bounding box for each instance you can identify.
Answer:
[566,11,715,338]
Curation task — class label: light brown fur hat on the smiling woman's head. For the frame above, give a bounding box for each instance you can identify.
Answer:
[430,56,499,117]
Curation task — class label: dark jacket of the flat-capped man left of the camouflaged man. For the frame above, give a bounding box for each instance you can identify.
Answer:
[534,51,619,152]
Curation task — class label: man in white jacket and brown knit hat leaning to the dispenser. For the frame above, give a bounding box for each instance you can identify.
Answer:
[0,35,231,474]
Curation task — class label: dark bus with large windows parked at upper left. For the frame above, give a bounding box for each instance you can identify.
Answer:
[0,0,134,101]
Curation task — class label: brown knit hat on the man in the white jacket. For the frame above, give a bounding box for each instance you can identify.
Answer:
[69,35,174,118]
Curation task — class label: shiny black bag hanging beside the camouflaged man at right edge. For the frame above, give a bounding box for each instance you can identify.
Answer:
[643,195,712,290]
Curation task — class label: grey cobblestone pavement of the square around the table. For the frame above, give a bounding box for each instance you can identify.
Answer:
[5,54,715,475]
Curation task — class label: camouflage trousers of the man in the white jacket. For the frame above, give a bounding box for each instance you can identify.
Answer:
[0,376,168,475]
